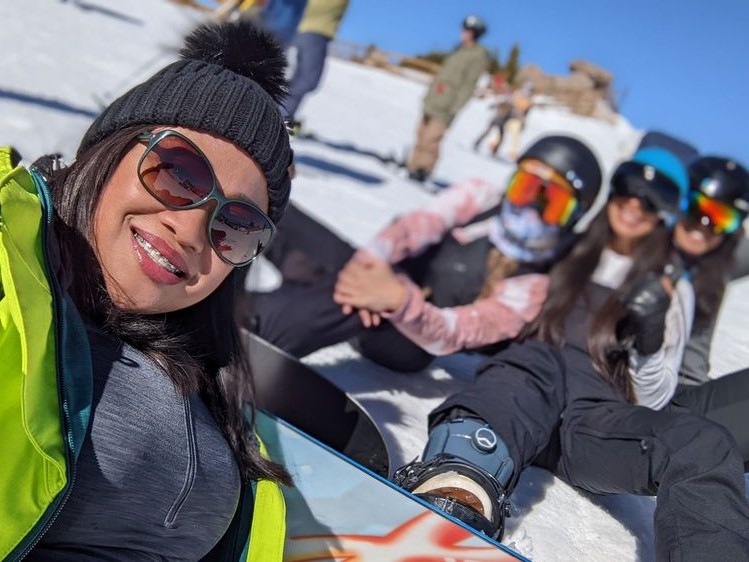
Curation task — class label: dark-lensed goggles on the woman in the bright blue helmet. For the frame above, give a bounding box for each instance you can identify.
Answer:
[611,162,681,221]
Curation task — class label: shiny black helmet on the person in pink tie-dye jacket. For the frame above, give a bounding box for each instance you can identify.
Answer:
[518,135,603,219]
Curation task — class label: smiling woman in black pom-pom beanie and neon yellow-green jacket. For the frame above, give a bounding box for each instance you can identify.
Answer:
[0,17,292,560]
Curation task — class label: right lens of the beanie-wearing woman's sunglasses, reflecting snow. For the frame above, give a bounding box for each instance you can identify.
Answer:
[211,203,273,265]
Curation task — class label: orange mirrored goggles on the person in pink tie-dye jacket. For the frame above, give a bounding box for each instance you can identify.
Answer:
[505,168,578,226]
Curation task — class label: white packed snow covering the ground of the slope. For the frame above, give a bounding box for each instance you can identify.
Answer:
[0,0,749,561]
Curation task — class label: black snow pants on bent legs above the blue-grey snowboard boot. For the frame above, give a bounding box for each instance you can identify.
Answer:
[430,342,749,561]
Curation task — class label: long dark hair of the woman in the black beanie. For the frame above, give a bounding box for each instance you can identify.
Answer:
[40,125,290,484]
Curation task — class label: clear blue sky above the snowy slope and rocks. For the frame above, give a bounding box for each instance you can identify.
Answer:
[338,0,749,165]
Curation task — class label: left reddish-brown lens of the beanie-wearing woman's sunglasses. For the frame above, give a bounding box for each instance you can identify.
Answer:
[139,135,213,207]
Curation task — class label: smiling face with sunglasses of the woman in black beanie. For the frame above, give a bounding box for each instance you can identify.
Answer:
[94,125,274,313]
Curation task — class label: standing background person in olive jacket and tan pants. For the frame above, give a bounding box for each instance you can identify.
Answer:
[406,16,489,181]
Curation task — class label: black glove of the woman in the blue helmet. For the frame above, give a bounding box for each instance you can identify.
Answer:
[620,273,671,355]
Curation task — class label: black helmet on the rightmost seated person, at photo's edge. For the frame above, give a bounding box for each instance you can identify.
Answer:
[687,156,749,217]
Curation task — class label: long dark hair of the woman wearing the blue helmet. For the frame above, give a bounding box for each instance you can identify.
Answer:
[521,203,670,402]
